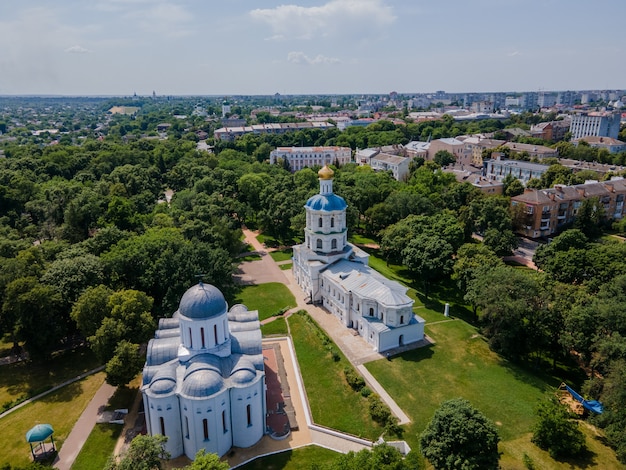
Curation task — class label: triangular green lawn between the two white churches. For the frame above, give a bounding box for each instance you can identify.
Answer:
[287,314,382,440]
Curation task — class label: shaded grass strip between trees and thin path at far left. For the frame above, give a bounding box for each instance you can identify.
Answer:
[0,346,100,405]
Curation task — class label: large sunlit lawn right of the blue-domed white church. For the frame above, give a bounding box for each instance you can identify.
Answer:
[365,319,622,469]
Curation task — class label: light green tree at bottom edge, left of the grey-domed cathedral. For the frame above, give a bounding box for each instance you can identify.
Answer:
[105,434,170,470]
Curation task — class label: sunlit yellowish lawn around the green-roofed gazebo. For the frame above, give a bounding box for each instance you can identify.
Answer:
[0,372,104,467]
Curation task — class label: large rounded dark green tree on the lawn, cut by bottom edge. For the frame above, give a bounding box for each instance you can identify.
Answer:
[420,398,500,470]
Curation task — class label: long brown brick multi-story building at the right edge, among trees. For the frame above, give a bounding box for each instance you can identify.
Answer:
[511,178,626,238]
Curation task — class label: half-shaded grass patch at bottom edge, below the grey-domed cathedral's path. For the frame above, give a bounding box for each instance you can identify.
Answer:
[239,445,339,470]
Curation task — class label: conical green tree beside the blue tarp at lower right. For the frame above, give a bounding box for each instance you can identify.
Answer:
[531,398,587,459]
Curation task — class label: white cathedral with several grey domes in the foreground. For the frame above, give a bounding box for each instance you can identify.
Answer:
[141,282,266,459]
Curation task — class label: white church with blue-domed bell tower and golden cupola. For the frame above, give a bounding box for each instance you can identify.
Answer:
[293,166,425,352]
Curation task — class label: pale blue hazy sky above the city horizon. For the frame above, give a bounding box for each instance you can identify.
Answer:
[0,0,626,96]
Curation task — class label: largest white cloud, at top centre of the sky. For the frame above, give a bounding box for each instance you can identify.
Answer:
[250,0,396,39]
